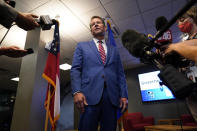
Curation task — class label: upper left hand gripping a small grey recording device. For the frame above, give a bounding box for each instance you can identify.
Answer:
[16,13,40,31]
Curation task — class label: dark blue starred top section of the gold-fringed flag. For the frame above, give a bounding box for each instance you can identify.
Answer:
[50,25,60,55]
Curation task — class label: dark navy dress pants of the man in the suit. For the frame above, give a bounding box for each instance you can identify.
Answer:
[79,86,117,131]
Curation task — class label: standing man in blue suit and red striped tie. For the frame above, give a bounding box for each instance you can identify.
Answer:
[71,16,128,131]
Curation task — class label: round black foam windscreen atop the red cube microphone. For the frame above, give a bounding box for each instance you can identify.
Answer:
[155,16,168,31]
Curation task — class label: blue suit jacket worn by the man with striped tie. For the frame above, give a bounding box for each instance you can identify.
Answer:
[71,40,128,106]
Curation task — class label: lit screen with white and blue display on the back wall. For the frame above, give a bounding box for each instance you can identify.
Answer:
[138,71,175,102]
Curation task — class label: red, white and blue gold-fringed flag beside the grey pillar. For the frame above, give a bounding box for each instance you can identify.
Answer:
[42,22,60,131]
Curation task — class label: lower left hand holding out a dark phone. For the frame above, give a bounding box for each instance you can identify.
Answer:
[0,46,28,58]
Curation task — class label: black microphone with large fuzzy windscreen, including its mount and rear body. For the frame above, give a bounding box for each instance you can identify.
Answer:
[122,29,190,68]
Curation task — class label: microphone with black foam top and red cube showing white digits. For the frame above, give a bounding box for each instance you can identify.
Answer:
[155,16,172,45]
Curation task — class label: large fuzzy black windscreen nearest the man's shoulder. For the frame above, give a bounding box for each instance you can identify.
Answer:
[122,30,152,57]
